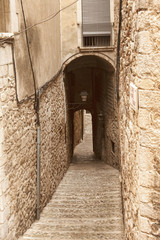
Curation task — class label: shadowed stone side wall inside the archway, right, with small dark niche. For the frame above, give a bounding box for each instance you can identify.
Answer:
[103,73,120,169]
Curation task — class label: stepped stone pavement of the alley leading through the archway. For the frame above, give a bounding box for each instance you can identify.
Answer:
[19,135,123,240]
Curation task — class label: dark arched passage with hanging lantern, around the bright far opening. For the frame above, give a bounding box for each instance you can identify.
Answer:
[64,55,119,167]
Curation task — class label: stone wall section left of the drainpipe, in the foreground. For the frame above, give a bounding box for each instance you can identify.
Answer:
[0,44,36,240]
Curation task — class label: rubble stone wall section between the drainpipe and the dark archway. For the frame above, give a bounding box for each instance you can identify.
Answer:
[40,76,70,209]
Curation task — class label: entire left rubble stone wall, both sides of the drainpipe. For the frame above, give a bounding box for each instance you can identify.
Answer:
[0,44,70,240]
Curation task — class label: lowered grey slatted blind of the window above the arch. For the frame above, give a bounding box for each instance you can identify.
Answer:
[82,0,111,36]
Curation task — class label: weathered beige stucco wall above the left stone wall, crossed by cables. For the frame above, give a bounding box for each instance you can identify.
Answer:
[15,0,61,100]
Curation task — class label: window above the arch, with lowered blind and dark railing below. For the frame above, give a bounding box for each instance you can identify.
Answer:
[82,0,112,47]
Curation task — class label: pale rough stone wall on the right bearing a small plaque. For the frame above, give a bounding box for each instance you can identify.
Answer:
[119,0,160,240]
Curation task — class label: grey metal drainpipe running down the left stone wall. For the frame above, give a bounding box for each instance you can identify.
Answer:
[35,90,41,220]
